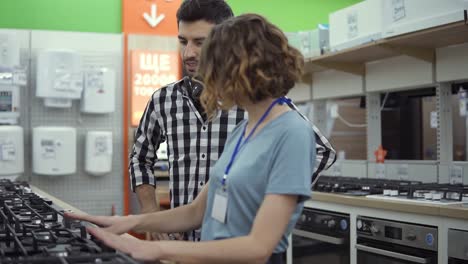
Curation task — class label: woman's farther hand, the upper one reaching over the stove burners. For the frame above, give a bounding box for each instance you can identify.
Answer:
[64,213,138,235]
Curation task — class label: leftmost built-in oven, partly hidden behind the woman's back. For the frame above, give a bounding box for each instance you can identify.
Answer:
[292,208,350,264]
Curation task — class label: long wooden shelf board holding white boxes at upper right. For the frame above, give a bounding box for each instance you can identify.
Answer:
[305,22,468,76]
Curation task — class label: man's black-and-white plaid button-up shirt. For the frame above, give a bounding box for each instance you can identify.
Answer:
[129,79,336,208]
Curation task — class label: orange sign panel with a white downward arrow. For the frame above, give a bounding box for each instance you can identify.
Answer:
[122,0,182,36]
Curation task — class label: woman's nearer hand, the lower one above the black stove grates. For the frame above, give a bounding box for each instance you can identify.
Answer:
[87,227,161,262]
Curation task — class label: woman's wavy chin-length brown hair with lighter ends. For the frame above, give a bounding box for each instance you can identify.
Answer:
[198,14,304,119]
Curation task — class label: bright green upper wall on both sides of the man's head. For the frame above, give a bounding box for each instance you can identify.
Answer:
[0,0,360,33]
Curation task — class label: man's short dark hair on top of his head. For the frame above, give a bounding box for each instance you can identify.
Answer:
[177,0,234,25]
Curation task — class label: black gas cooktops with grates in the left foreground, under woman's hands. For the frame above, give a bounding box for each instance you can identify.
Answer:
[0,180,139,264]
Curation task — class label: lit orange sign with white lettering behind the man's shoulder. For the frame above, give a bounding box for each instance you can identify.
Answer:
[130,50,180,126]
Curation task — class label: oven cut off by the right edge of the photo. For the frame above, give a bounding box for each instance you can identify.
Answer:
[448,229,468,264]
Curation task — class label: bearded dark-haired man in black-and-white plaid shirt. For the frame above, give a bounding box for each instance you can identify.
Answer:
[129,0,335,240]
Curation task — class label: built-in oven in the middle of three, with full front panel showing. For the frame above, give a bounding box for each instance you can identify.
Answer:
[356,216,437,264]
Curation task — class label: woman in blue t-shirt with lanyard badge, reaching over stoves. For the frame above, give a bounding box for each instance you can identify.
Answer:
[68,14,315,263]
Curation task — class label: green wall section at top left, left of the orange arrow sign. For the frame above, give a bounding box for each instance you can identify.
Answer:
[0,0,122,33]
